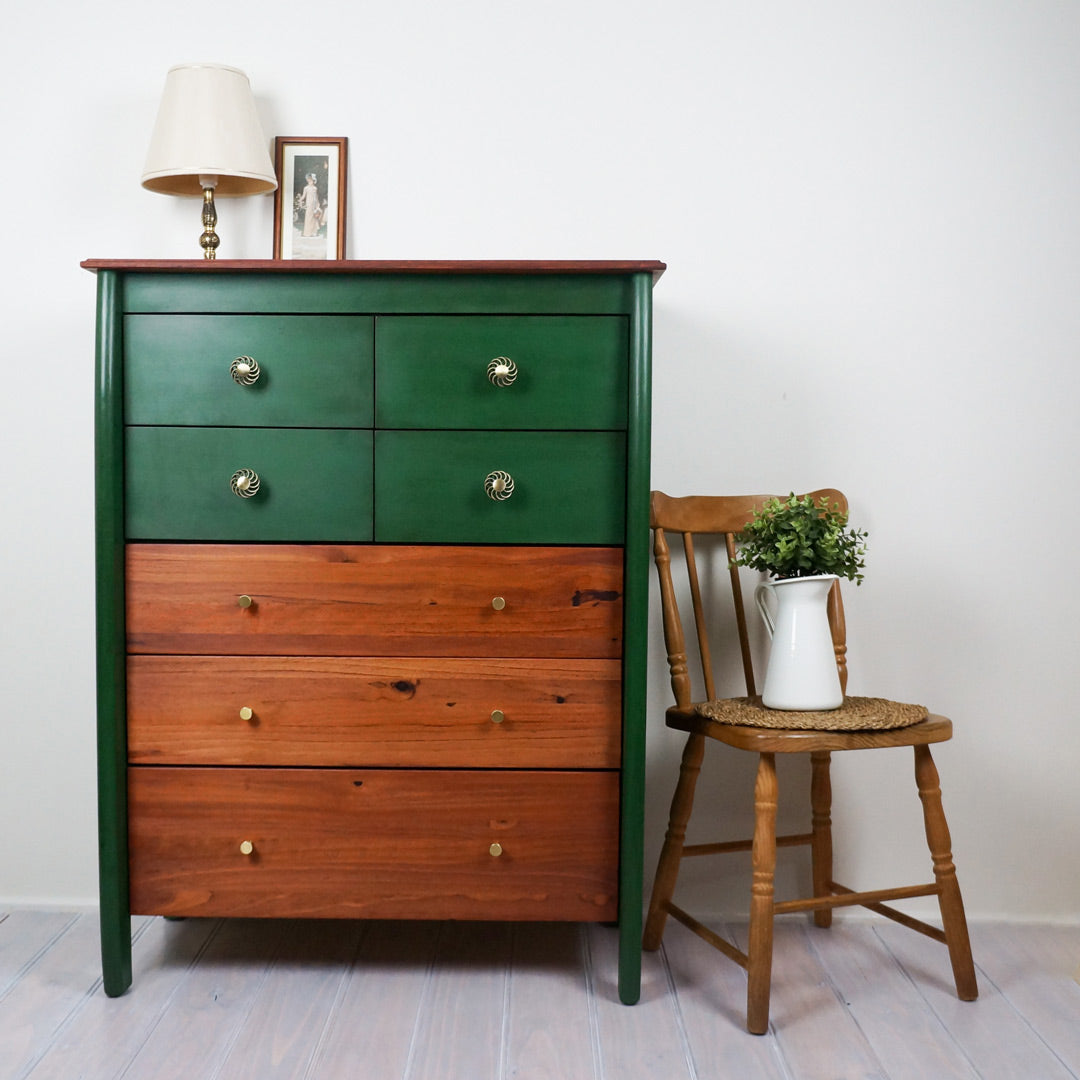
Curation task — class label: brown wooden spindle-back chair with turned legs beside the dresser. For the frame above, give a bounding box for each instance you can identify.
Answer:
[644,489,978,1035]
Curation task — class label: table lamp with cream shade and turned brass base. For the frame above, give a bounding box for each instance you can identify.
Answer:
[143,64,278,259]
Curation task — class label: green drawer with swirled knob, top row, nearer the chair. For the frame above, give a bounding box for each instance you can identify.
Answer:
[375,315,629,430]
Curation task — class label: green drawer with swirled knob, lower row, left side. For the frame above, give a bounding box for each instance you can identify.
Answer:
[125,428,372,541]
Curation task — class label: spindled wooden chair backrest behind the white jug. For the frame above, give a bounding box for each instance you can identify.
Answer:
[650,488,848,705]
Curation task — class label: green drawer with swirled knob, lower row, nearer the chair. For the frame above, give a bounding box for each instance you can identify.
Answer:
[375,431,626,544]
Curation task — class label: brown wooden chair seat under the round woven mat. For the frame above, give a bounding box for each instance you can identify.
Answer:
[664,702,953,754]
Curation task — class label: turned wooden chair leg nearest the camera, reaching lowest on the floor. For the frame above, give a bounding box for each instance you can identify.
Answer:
[746,754,778,1035]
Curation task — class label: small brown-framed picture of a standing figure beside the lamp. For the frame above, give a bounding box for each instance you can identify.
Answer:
[273,135,349,259]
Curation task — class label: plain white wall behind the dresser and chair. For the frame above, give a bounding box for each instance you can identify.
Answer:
[0,0,1080,919]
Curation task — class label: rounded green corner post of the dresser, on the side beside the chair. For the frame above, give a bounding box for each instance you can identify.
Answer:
[619,273,652,1005]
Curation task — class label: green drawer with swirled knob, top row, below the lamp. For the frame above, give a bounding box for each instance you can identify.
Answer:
[124,315,375,428]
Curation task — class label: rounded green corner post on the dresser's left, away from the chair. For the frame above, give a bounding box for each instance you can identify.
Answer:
[94,270,132,997]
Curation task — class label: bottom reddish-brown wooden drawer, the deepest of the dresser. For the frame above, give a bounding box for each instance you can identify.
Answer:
[129,766,619,921]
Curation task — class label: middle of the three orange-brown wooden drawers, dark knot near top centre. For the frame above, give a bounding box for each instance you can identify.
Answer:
[127,657,622,769]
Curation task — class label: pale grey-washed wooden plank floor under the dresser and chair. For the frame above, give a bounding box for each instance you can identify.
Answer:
[0,909,1080,1080]
